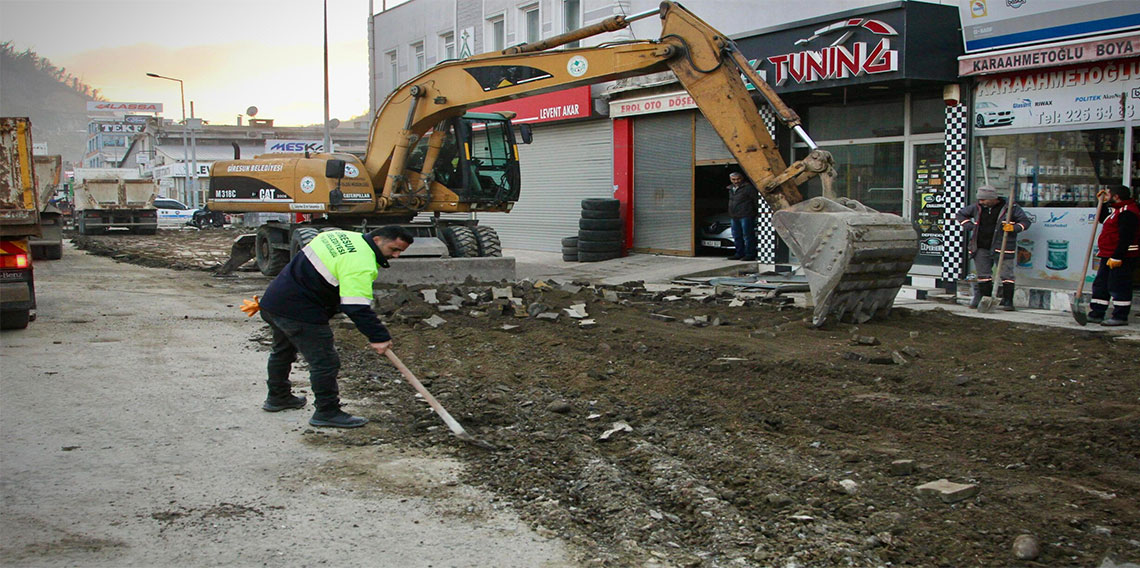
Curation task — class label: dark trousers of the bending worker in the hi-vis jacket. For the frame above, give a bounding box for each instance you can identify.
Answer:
[261,310,341,413]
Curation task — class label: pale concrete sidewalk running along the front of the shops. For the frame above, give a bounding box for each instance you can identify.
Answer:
[503,249,1140,341]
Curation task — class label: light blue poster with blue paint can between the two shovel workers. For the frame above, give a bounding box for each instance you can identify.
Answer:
[1016,208,1099,284]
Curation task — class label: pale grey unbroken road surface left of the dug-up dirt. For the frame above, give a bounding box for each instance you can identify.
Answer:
[0,249,573,567]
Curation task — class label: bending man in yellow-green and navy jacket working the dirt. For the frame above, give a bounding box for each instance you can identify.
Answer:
[242,226,414,428]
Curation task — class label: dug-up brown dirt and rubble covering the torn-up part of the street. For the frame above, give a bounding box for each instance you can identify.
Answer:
[11,230,1140,568]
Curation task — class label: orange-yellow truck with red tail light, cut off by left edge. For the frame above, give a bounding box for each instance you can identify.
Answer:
[0,117,41,330]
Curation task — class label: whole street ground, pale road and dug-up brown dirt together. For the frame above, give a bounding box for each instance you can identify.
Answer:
[22,234,1140,568]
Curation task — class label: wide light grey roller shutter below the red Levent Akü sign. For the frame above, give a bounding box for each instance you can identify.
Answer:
[479,120,613,252]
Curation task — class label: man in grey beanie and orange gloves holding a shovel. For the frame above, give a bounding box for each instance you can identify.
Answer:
[958,184,1031,311]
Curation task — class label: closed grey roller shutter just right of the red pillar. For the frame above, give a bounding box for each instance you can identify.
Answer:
[634,113,694,254]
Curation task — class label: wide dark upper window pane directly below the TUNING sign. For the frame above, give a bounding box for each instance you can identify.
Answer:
[807,99,903,140]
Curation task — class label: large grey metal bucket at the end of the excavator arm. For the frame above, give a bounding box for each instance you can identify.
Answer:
[772,197,918,326]
